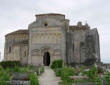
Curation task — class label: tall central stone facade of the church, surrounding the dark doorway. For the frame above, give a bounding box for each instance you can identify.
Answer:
[28,15,69,65]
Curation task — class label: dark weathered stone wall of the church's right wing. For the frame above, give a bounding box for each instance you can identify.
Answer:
[67,29,100,64]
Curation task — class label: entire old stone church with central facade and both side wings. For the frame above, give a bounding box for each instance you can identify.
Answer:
[4,13,100,66]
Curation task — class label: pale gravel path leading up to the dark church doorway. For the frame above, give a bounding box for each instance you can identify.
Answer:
[39,67,60,85]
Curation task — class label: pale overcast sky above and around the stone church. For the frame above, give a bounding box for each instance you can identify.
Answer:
[0,0,110,63]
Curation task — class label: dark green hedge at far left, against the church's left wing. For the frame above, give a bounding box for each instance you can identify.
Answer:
[0,61,21,68]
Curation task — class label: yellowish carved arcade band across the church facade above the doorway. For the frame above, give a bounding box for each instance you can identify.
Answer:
[32,32,61,44]
